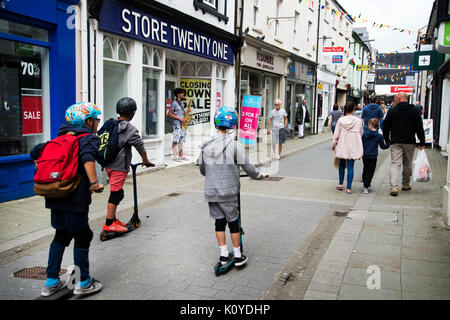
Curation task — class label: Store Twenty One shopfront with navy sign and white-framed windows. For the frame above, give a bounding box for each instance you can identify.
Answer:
[91,0,237,163]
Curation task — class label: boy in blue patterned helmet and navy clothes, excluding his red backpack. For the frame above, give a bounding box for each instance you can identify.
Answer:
[30,102,103,297]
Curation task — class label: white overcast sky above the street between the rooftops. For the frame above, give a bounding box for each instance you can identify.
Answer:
[338,0,434,53]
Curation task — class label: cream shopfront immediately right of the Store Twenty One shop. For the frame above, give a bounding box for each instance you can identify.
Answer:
[240,36,288,133]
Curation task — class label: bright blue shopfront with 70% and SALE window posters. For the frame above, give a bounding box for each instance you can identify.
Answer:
[0,0,78,202]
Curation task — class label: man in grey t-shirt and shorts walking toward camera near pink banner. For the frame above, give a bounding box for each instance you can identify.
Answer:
[267,99,287,160]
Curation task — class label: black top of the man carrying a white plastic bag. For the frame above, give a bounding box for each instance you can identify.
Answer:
[383,102,425,146]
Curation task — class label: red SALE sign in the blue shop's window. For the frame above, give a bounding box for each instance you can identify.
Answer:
[21,95,42,136]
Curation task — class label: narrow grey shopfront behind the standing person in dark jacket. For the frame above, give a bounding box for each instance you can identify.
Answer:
[286,55,316,133]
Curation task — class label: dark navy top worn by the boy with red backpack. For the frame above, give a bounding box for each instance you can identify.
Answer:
[30,125,100,213]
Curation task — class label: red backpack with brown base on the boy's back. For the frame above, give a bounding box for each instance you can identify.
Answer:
[33,133,89,199]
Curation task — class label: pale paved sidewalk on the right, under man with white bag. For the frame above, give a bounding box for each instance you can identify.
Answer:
[263,149,450,300]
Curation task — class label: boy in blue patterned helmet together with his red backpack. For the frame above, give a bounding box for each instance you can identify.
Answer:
[30,102,103,296]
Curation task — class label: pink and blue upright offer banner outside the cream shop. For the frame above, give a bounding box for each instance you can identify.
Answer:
[239,95,262,145]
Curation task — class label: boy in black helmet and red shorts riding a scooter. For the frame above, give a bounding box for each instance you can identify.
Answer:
[98,97,154,233]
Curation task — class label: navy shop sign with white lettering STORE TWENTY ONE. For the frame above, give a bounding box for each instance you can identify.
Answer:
[99,0,234,64]
